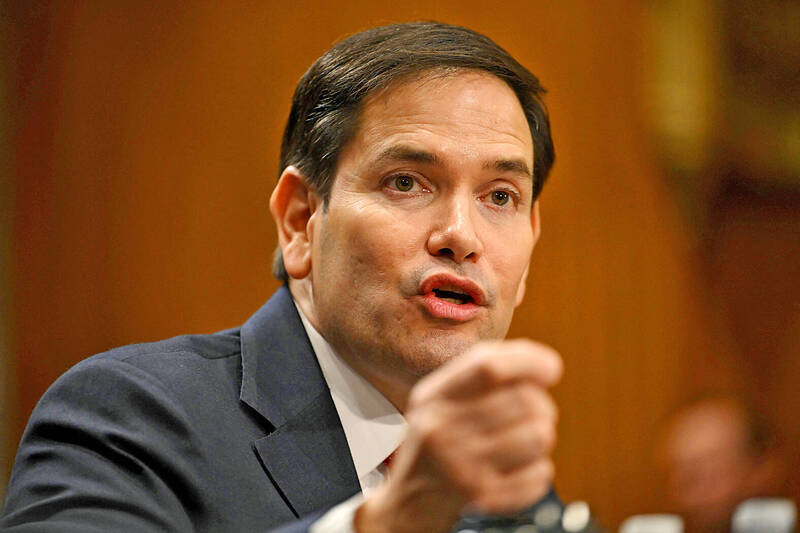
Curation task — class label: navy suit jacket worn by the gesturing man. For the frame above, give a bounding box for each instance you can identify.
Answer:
[0,288,359,533]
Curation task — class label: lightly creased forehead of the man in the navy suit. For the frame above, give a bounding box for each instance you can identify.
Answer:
[345,70,533,168]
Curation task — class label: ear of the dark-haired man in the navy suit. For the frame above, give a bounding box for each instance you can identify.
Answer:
[269,166,319,279]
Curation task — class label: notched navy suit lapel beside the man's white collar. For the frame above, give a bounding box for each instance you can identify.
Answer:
[240,287,360,516]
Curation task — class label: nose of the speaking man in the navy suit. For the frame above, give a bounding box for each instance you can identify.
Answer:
[427,196,483,264]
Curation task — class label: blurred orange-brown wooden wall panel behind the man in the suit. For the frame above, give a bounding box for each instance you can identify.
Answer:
[6,0,756,525]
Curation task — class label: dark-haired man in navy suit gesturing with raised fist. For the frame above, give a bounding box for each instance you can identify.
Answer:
[2,23,561,533]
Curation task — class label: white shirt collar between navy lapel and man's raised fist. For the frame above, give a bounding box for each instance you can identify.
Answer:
[295,302,407,488]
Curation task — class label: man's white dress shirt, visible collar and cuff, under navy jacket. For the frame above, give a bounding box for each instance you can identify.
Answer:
[295,303,407,533]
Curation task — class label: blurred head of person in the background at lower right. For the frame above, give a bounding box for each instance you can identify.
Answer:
[656,394,787,533]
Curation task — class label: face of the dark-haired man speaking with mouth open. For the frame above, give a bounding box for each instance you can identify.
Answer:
[307,71,538,404]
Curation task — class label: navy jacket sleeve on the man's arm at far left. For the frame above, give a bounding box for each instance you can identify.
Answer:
[0,358,206,533]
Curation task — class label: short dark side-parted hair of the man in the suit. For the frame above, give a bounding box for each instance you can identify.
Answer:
[273,22,555,282]
